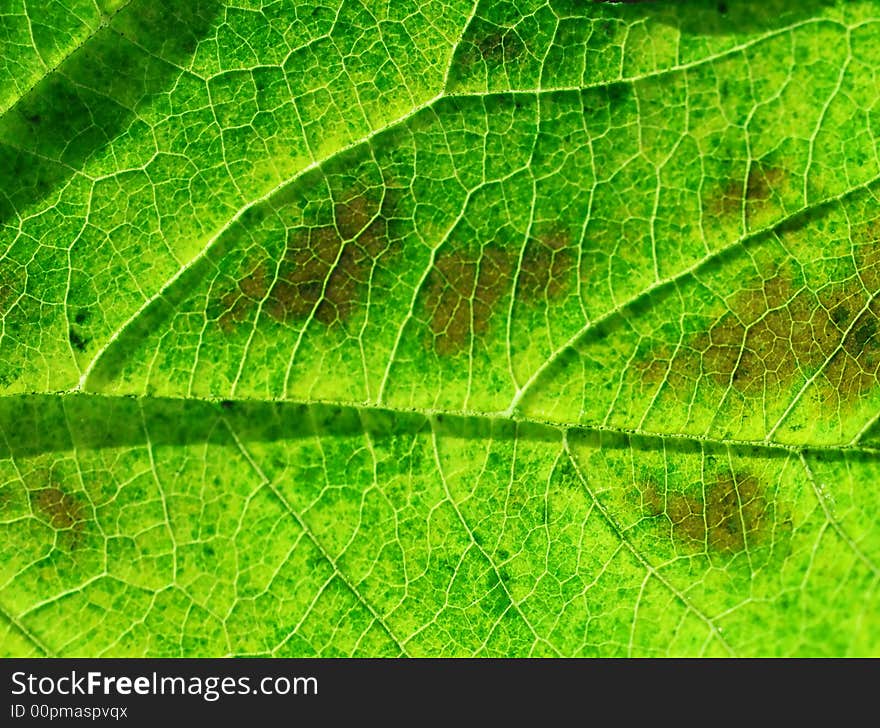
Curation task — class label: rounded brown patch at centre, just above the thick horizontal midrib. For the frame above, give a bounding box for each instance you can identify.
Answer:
[425,247,518,355]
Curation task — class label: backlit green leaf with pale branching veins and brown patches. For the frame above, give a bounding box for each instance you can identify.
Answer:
[0,0,880,656]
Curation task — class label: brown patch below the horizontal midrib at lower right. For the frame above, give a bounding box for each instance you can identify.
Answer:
[639,472,774,555]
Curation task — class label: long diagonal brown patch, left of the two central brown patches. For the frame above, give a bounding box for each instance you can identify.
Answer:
[218,183,396,333]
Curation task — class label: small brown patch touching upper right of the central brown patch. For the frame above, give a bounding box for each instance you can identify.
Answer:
[516,232,577,301]
